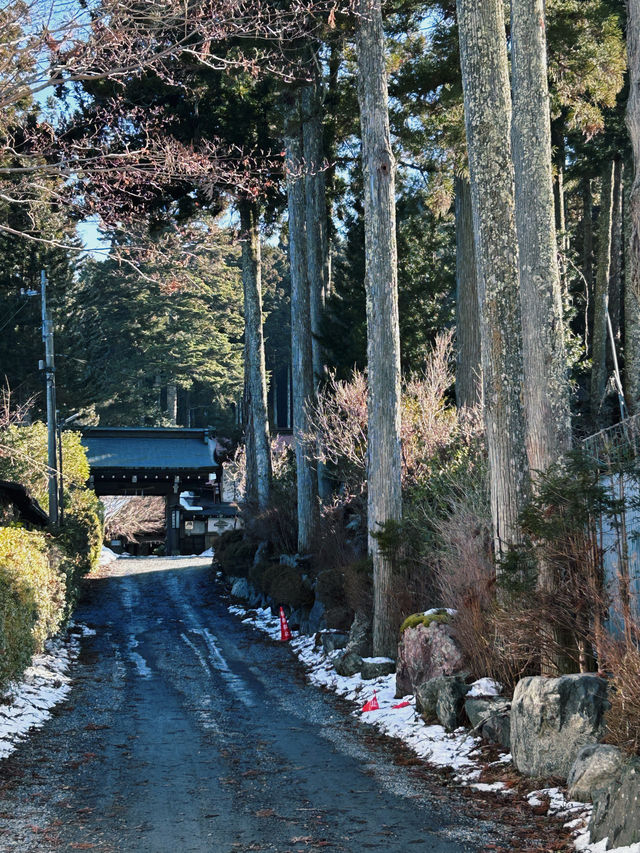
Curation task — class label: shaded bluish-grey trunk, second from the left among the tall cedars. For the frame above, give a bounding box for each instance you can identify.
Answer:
[285,94,317,552]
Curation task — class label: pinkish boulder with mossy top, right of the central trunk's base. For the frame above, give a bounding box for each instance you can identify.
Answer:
[396,618,464,697]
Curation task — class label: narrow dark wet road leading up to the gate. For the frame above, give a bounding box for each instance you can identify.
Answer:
[0,559,508,853]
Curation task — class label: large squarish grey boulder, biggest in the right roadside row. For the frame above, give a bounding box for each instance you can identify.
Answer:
[511,674,609,779]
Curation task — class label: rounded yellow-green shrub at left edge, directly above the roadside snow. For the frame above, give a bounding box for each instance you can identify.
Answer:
[0,527,65,685]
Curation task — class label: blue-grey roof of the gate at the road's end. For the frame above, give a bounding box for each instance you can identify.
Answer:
[82,427,220,471]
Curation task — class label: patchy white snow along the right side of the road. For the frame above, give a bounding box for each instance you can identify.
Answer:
[229,604,640,853]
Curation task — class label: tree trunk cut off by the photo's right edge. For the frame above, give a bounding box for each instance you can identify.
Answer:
[625,0,640,414]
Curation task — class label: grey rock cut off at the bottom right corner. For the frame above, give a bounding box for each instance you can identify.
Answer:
[589,758,640,850]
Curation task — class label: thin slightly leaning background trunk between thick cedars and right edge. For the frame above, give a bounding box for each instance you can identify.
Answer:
[591,162,614,429]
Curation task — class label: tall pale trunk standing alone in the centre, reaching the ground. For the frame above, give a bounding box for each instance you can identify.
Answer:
[357,0,402,657]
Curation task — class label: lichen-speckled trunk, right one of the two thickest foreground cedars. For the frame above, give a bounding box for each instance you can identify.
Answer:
[511,0,571,481]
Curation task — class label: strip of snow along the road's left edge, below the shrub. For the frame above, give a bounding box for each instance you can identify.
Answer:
[0,624,95,759]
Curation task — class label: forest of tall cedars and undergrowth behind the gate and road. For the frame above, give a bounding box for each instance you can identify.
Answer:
[0,0,640,748]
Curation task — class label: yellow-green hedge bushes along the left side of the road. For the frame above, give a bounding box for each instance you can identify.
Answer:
[0,422,102,693]
